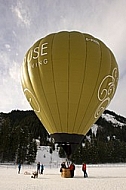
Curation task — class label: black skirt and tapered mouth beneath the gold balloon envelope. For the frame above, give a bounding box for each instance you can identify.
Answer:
[50,133,84,159]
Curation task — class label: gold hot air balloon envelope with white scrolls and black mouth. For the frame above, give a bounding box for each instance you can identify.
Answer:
[21,31,119,157]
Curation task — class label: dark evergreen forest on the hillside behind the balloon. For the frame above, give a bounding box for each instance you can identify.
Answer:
[0,110,126,164]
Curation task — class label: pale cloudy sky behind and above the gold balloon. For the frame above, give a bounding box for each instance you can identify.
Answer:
[0,0,126,117]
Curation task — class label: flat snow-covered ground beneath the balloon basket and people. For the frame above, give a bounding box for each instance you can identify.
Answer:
[0,164,126,190]
